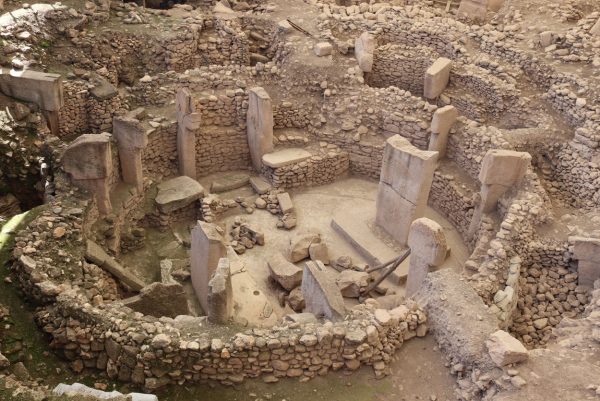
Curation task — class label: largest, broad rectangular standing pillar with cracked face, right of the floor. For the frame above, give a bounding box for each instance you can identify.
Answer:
[375,135,438,245]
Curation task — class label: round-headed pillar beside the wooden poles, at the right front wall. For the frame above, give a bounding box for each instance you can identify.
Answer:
[406,217,448,297]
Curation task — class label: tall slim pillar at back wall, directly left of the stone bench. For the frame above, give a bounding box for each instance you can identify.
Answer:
[246,87,273,172]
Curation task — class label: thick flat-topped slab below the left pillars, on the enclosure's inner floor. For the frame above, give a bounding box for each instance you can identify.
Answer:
[154,175,204,213]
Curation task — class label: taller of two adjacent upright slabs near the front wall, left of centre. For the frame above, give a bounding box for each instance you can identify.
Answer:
[191,221,227,313]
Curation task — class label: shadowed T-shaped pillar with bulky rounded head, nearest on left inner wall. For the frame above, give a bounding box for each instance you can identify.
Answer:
[63,133,112,214]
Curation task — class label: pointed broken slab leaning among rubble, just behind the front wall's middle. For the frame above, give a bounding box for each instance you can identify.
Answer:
[302,261,346,321]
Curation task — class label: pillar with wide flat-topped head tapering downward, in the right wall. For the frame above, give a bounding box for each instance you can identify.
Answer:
[469,149,531,236]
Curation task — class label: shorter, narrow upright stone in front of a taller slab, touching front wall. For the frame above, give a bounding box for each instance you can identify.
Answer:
[206,258,233,324]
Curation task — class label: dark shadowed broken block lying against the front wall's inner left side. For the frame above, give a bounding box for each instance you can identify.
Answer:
[123,282,190,318]
